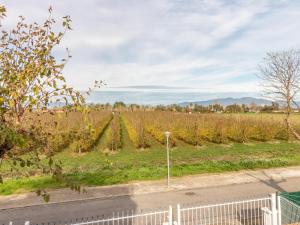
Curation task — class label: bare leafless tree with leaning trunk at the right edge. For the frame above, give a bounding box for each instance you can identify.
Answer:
[258,50,300,140]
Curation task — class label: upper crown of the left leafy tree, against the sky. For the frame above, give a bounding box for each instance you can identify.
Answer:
[0,8,84,123]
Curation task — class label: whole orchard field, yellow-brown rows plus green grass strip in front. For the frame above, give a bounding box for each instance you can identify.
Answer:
[0,110,300,195]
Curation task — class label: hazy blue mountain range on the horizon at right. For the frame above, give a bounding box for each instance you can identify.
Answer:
[179,97,272,106]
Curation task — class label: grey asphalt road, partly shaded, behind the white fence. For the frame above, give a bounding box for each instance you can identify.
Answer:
[0,178,300,225]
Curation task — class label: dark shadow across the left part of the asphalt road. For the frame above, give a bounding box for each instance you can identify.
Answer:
[0,187,137,225]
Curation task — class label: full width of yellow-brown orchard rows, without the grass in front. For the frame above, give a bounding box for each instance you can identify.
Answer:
[18,110,300,153]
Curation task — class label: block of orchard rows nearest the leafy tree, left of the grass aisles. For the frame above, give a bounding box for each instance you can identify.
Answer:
[26,110,111,152]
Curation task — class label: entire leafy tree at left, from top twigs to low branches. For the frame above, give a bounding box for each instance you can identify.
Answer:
[0,6,102,200]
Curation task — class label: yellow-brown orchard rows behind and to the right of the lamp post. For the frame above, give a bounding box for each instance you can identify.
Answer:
[127,112,300,145]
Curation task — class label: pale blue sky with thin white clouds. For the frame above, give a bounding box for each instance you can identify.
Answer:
[0,0,300,92]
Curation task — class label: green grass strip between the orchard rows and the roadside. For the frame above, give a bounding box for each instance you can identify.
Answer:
[0,140,300,195]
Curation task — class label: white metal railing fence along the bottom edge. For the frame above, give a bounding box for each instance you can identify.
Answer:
[10,194,284,225]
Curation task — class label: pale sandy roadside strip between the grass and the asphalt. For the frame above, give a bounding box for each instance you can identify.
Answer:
[0,166,300,209]
